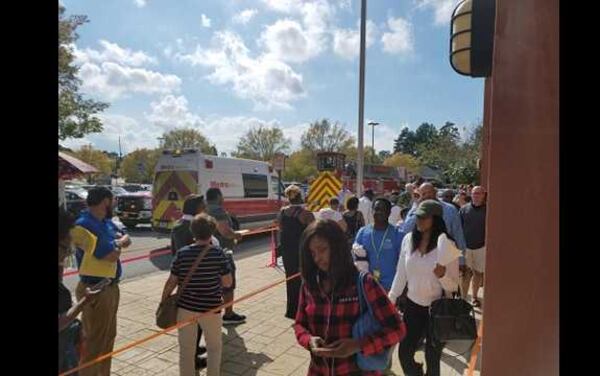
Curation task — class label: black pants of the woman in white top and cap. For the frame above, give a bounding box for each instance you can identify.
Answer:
[398,298,443,376]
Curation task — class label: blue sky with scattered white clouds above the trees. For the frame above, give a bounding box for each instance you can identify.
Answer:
[60,0,483,154]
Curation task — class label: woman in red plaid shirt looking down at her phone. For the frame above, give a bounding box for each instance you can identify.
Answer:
[294,220,406,375]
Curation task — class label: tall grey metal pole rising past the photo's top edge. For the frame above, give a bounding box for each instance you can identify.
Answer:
[356,0,367,196]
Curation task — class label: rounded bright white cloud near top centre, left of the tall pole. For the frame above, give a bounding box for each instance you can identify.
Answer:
[259,19,321,63]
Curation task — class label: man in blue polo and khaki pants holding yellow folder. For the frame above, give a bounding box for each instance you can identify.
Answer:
[72,187,131,376]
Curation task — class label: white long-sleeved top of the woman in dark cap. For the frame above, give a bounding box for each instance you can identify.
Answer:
[388,233,460,307]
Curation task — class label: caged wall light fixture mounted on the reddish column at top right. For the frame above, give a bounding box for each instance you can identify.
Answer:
[450,0,496,77]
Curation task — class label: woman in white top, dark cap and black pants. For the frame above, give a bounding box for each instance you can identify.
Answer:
[388,200,460,376]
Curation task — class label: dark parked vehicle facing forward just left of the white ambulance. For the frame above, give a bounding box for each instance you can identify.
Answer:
[115,191,152,229]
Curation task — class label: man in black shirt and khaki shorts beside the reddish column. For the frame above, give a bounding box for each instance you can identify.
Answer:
[459,186,486,307]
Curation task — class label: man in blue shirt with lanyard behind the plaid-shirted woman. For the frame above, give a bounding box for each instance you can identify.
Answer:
[352,198,403,291]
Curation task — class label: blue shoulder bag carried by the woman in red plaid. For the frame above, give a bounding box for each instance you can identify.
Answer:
[352,272,394,371]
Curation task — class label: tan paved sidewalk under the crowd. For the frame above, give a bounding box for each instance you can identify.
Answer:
[101,250,479,376]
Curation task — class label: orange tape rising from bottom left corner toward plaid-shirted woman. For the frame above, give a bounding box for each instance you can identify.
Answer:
[59,273,300,376]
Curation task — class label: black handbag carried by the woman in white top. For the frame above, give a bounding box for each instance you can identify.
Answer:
[429,294,477,343]
